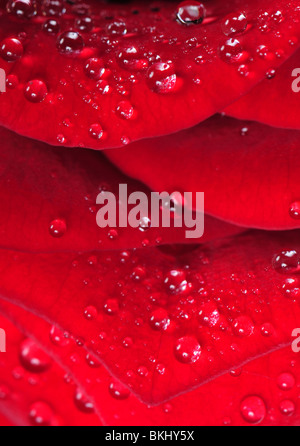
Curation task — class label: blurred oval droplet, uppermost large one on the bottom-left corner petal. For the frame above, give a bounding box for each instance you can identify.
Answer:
[20,339,51,373]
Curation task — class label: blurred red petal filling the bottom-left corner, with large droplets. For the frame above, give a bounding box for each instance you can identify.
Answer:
[0,316,101,426]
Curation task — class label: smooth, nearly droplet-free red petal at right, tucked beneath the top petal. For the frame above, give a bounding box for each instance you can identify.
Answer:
[106,116,300,229]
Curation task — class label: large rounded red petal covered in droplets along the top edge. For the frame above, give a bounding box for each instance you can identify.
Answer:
[0,0,300,149]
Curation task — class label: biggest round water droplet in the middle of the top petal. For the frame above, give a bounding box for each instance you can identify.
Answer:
[147,62,177,94]
